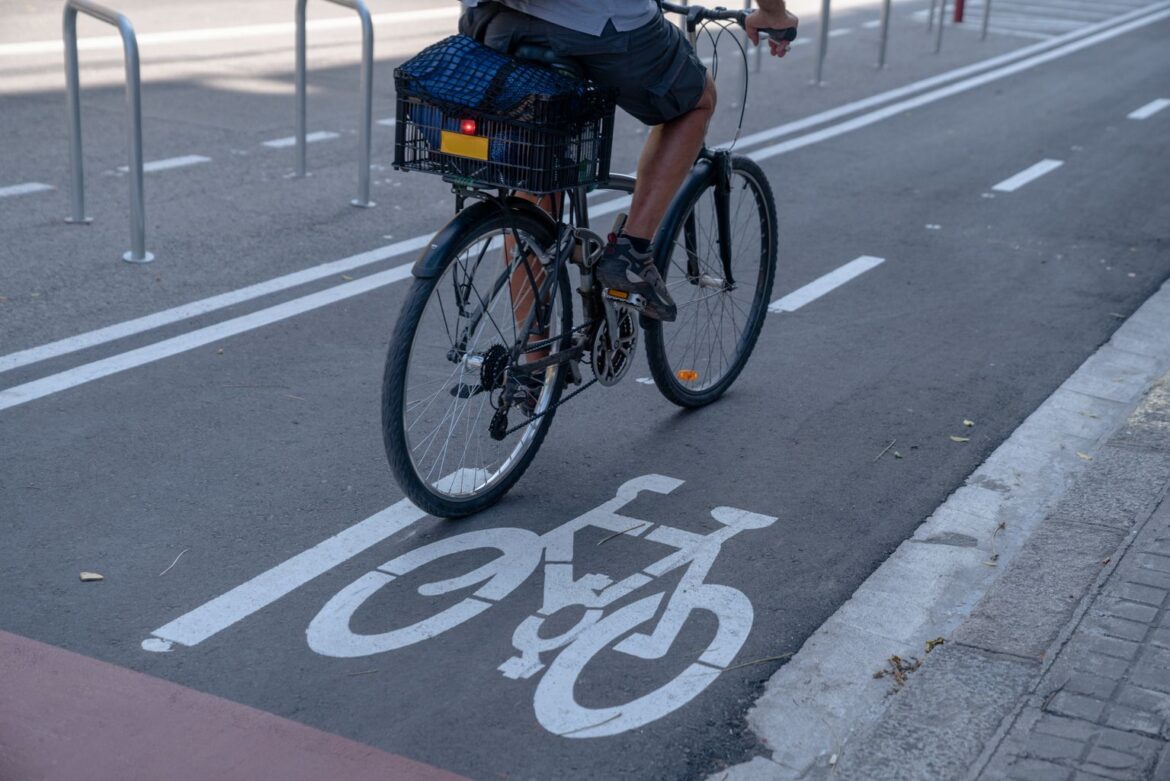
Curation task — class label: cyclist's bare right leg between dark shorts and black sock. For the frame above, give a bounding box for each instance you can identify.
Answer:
[625,75,715,241]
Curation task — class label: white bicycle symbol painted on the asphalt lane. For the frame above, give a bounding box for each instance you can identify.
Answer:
[307,475,776,738]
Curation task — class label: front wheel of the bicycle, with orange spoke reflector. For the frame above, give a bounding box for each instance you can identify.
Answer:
[645,157,777,407]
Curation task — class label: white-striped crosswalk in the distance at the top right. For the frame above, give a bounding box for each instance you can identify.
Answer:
[914,0,1149,39]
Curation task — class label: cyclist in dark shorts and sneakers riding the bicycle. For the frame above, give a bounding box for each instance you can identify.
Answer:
[459,0,799,320]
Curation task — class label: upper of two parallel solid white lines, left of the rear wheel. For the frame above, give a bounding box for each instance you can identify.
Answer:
[0,236,431,372]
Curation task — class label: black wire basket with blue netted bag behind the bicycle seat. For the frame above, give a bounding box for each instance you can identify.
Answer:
[394,35,614,194]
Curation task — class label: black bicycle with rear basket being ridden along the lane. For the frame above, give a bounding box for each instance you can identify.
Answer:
[383,2,796,517]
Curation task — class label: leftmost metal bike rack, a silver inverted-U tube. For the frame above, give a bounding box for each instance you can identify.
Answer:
[63,0,154,263]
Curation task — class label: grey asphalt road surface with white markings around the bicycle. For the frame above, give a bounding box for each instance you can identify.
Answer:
[0,1,1170,779]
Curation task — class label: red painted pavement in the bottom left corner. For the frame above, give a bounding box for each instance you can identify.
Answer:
[0,631,475,781]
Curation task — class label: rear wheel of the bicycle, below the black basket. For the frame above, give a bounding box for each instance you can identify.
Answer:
[383,203,572,518]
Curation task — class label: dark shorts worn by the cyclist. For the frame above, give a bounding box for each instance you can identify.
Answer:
[459,2,707,125]
